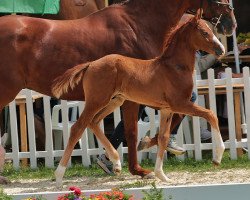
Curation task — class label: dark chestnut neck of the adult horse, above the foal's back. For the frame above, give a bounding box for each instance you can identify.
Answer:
[123,0,190,53]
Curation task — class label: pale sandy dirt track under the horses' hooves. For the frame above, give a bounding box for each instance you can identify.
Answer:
[3,169,250,194]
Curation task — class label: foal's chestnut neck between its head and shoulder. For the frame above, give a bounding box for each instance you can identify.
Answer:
[157,22,196,72]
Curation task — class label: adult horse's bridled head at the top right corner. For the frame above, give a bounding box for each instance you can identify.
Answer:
[190,0,237,35]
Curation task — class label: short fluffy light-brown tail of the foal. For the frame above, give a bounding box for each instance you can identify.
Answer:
[52,62,90,98]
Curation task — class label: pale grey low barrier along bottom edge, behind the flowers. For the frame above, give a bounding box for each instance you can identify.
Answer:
[4,183,250,200]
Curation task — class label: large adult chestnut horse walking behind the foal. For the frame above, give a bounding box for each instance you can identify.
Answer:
[0,0,236,176]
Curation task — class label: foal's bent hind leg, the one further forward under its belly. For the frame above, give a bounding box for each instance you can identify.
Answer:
[89,96,124,173]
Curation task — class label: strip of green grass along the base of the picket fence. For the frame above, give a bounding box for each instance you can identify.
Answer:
[3,151,250,180]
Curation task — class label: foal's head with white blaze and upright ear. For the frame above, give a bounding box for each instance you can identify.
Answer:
[189,9,225,56]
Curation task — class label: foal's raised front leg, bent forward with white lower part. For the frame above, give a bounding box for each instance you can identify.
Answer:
[172,102,225,165]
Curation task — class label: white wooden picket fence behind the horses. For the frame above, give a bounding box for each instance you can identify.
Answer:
[3,67,250,168]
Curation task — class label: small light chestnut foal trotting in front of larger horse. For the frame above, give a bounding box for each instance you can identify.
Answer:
[52,12,225,185]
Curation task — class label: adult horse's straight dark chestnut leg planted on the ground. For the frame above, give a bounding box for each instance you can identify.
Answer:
[122,101,152,177]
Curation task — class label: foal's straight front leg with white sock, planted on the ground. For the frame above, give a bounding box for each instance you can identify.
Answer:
[154,109,173,182]
